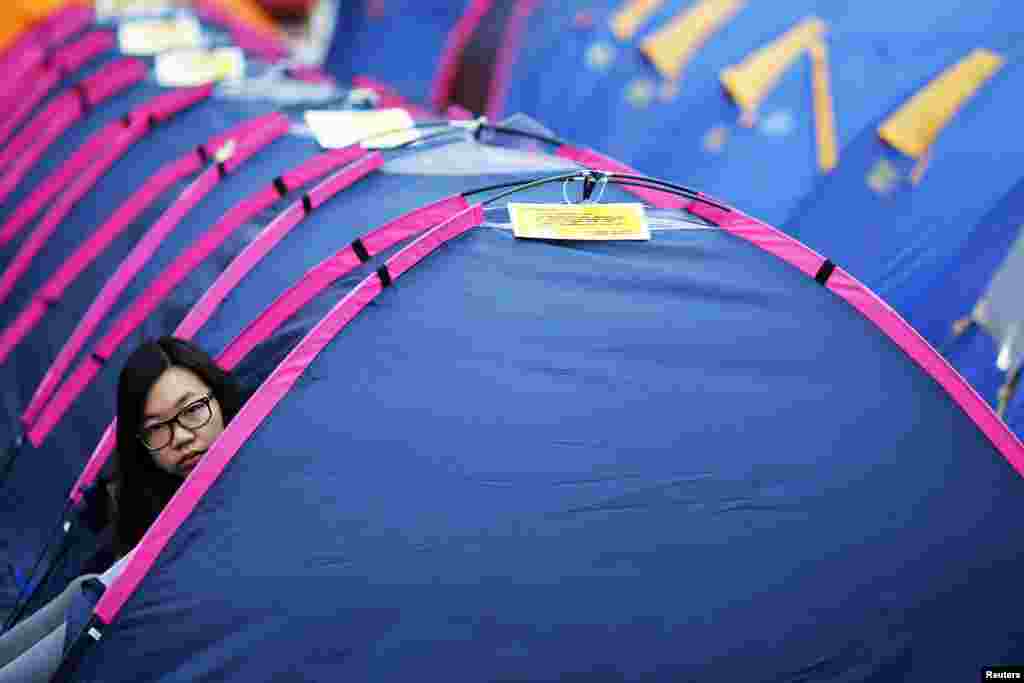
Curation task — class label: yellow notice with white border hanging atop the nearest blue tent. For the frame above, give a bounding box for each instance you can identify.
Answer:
[508,203,650,242]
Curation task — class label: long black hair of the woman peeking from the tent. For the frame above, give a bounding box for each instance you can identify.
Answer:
[114,337,244,555]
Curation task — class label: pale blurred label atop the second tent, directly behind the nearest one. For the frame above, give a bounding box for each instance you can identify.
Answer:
[305,109,420,150]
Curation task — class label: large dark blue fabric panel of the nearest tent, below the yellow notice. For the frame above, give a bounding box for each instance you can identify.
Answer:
[64,184,1022,681]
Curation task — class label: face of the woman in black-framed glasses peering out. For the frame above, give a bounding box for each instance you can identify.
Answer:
[139,366,224,477]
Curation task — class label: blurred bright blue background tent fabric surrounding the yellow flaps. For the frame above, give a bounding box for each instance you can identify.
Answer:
[483,1,1020,428]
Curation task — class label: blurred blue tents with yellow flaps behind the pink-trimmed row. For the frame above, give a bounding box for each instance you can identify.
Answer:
[328,0,1024,429]
